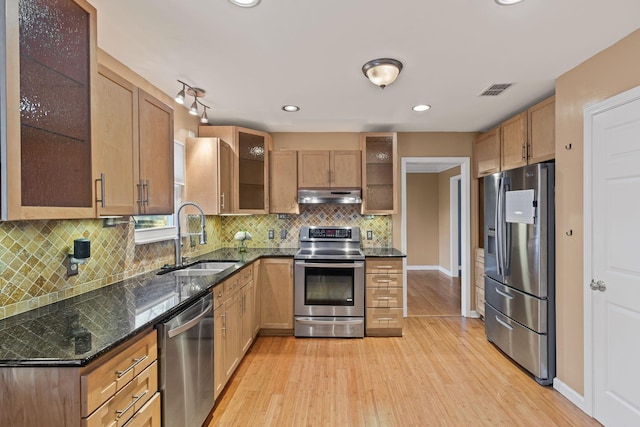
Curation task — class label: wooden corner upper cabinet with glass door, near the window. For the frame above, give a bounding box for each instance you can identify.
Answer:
[199,126,273,214]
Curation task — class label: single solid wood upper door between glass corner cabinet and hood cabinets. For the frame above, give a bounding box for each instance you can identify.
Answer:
[269,151,300,214]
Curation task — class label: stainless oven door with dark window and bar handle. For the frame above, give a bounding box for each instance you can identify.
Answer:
[294,260,364,317]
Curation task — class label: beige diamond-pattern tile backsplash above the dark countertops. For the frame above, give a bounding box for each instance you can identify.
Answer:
[0,205,392,319]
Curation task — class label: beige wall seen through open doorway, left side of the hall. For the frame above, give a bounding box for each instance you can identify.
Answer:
[407,173,440,266]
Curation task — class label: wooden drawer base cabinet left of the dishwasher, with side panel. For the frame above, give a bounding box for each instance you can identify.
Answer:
[0,329,161,427]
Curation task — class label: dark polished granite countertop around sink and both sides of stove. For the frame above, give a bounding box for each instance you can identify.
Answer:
[0,248,405,367]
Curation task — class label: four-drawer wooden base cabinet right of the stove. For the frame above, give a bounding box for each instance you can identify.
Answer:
[365,258,403,337]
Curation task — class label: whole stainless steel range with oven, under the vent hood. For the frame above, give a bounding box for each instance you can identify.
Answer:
[294,226,365,338]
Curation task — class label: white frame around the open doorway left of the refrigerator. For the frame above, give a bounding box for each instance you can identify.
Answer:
[400,157,472,318]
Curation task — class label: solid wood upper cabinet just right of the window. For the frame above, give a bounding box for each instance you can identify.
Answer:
[185,138,233,215]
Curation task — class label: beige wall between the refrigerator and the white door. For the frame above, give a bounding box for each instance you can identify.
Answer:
[556,30,640,394]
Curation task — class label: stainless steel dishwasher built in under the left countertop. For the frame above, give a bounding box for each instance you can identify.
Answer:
[157,293,214,427]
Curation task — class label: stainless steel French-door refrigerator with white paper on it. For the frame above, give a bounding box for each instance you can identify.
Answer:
[484,163,556,385]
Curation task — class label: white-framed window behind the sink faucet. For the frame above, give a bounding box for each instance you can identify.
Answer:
[134,141,185,245]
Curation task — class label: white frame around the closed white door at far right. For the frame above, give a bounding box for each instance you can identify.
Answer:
[582,86,640,416]
